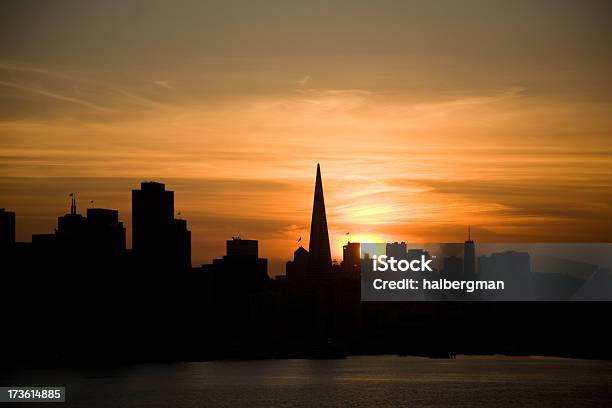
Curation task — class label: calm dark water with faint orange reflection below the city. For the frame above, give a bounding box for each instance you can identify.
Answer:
[1,356,612,408]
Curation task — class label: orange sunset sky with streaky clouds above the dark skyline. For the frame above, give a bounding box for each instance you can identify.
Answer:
[0,0,612,274]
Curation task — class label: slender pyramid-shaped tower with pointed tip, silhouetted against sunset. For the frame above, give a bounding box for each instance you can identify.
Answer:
[308,164,332,274]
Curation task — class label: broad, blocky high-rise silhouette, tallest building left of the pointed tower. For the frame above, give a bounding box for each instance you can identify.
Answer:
[132,181,191,268]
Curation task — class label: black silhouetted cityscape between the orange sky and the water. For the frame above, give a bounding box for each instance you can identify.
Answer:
[0,165,612,364]
